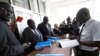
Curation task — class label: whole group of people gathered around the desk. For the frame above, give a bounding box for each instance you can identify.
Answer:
[0,2,100,56]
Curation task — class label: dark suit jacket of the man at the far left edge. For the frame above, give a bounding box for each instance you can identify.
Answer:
[0,20,24,56]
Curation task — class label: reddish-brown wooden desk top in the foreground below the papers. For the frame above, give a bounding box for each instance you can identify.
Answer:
[27,47,71,56]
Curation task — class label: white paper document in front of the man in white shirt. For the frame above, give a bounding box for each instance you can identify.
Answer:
[59,39,79,48]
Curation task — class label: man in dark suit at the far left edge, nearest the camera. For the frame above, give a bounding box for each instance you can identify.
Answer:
[0,2,25,56]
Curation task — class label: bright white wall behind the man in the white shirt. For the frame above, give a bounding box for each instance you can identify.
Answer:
[46,0,100,27]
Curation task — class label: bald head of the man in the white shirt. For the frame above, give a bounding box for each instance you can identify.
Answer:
[76,8,90,24]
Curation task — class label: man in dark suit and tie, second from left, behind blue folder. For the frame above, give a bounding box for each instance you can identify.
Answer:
[22,19,43,53]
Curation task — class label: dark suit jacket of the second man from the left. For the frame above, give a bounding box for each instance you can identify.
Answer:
[22,27,43,52]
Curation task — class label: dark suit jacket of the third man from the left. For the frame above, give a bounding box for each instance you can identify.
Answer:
[37,23,53,39]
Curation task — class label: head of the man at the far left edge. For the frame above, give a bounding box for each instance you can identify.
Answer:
[0,6,13,21]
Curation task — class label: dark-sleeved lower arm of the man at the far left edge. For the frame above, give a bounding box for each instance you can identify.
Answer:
[0,29,24,56]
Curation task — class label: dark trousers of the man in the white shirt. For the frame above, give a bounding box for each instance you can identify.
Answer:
[78,49,99,56]
